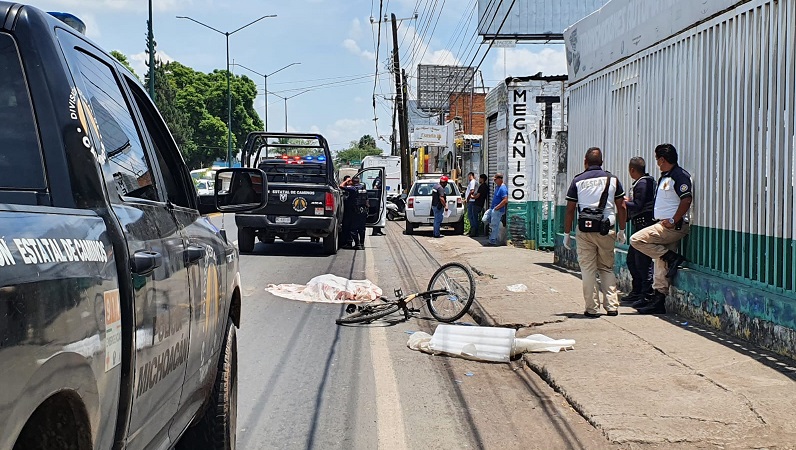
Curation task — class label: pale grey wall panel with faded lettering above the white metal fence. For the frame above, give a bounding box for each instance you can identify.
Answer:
[564,0,749,81]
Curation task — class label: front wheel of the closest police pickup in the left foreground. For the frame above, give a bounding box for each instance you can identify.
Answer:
[176,319,238,450]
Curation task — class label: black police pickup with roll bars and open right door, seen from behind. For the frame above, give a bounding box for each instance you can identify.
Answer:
[235,131,386,255]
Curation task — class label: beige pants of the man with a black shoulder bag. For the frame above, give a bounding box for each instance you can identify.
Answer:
[575,231,619,314]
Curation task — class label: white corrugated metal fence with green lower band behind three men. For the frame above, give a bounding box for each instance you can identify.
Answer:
[568,0,796,292]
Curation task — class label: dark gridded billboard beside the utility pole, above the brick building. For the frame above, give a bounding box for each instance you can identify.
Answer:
[417,64,475,113]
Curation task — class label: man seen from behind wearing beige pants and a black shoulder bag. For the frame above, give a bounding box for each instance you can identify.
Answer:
[564,147,627,317]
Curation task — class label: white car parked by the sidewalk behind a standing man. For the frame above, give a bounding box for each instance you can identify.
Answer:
[406,178,464,234]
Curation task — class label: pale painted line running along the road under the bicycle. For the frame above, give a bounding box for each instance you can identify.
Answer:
[365,247,407,450]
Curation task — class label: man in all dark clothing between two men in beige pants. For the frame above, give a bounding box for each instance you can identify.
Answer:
[622,156,655,303]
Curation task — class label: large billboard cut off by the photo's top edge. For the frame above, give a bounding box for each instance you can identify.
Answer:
[478,0,608,41]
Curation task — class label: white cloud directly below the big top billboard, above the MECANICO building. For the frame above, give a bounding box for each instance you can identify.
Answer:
[492,47,567,79]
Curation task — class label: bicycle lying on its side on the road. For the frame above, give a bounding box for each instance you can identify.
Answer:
[335,262,475,325]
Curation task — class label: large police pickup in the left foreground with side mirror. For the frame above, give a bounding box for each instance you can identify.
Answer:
[0,1,267,450]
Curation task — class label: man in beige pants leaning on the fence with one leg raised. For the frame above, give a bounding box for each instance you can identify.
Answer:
[630,144,694,314]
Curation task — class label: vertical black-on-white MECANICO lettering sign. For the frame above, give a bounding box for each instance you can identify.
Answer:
[505,88,528,202]
